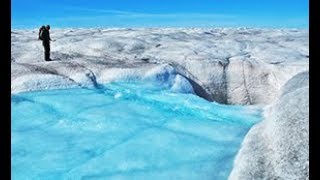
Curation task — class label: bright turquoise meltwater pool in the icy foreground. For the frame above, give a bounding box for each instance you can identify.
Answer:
[11,81,261,180]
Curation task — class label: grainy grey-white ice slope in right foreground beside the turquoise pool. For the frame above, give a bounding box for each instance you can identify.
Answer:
[229,72,309,180]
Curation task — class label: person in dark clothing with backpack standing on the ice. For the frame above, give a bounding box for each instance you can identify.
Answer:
[39,25,52,61]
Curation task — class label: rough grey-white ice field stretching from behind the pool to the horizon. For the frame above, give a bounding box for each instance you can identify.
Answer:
[11,27,309,104]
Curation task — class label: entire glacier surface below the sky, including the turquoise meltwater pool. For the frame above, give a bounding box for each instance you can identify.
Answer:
[11,27,309,179]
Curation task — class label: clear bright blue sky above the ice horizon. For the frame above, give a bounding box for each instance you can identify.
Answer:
[11,0,309,28]
